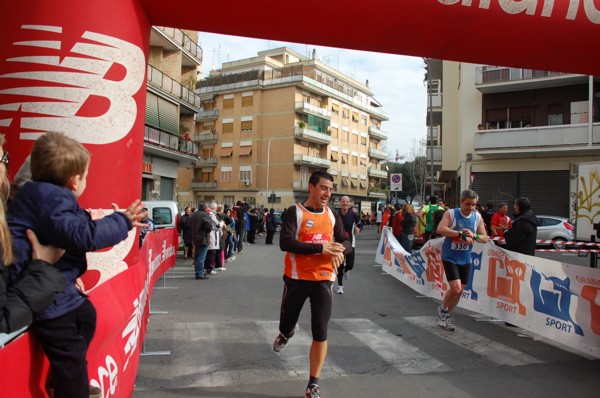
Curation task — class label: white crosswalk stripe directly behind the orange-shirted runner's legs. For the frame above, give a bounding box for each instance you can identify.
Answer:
[255,321,348,378]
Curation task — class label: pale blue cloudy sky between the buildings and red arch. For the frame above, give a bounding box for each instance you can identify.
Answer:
[198,32,427,160]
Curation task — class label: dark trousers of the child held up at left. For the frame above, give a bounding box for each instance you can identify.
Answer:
[31,298,96,398]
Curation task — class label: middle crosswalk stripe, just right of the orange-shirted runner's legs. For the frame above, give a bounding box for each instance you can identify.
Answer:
[333,318,452,374]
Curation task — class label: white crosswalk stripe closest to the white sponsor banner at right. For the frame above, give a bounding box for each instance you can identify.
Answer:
[404,316,544,366]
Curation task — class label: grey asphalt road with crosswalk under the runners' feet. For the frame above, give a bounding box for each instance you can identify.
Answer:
[134,230,600,398]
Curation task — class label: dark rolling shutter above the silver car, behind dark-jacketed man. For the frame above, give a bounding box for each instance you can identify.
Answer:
[519,170,569,217]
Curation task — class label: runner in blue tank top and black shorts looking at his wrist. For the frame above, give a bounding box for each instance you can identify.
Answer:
[437,189,488,331]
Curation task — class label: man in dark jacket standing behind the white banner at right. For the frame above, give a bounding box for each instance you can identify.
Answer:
[504,197,537,256]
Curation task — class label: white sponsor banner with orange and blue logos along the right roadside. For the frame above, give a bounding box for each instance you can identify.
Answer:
[375,228,600,358]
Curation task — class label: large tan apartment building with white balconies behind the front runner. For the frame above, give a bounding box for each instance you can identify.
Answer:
[192,47,388,211]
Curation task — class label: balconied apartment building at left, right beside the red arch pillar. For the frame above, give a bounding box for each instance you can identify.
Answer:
[142,26,202,204]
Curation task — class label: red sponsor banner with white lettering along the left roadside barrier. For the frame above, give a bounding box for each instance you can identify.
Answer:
[0,228,177,398]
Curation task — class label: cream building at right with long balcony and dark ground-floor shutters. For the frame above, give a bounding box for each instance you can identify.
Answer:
[437,61,600,218]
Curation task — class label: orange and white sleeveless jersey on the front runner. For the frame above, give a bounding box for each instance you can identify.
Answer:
[284,203,336,281]
